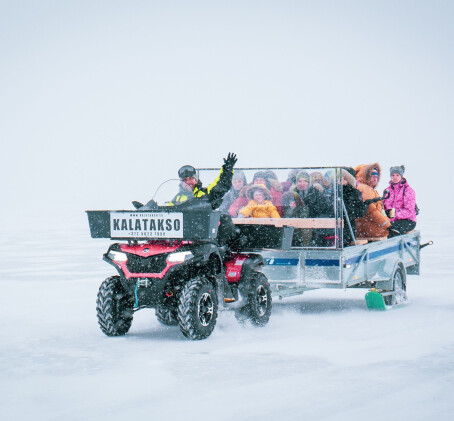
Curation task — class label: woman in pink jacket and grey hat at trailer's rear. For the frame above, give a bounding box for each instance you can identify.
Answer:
[383,165,416,238]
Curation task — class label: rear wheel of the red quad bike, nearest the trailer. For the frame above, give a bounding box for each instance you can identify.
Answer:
[235,273,272,326]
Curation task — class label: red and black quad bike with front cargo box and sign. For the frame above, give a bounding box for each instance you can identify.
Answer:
[87,182,271,339]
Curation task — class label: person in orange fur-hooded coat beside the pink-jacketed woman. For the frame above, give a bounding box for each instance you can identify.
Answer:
[355,163,391,238]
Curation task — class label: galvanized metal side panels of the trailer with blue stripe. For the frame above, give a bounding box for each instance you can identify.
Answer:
[247,231,420,299]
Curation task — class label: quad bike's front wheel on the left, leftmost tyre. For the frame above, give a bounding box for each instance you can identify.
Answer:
[96,276,134,336]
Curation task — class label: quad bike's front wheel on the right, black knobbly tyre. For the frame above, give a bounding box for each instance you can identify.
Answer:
[178,277,218,339]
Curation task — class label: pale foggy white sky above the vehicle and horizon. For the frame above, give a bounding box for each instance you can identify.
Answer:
[0,0,454,215]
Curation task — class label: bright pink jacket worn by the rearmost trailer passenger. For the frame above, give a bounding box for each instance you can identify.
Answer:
[383,178,416,222]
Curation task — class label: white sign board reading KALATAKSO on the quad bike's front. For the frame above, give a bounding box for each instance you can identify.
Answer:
[110,212,183,238]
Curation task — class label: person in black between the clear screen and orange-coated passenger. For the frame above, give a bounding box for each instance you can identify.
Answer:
[342,168,366,247]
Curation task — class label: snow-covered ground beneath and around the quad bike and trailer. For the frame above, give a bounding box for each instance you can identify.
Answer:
[0,212,454,421]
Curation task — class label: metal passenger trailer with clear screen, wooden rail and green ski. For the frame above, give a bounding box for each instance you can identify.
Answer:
[196,167,432,310]
